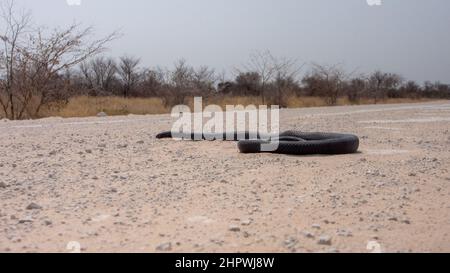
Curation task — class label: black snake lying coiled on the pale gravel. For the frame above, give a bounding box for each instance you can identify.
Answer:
[156,131,359,155]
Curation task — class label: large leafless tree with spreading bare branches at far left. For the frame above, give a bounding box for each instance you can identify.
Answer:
[0,1,117,119]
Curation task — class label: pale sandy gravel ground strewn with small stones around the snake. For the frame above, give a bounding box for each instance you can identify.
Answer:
[0,101,450,252]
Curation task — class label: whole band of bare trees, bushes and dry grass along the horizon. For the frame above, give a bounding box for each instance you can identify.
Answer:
[0,0,450,119]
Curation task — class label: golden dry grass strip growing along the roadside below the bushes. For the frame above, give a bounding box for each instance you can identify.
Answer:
[37,96,434,117]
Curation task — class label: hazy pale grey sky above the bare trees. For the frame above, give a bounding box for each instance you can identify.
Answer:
[12,0,450,83]
